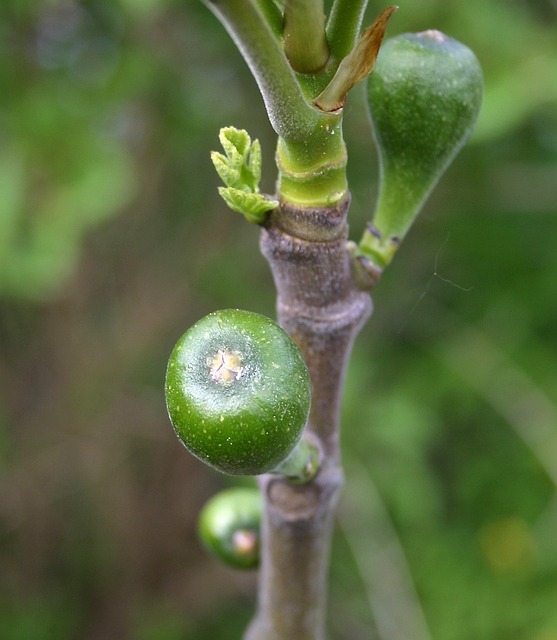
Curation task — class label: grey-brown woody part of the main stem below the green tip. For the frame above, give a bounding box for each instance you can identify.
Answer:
[245,198,372,640]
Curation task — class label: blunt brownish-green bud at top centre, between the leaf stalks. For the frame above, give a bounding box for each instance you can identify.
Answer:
[283,0,329,73]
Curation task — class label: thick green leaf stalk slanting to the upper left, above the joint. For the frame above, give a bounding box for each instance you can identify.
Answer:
[205,0,320,140]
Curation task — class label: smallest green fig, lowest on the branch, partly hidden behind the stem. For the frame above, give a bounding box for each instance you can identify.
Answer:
[198,487,262,569]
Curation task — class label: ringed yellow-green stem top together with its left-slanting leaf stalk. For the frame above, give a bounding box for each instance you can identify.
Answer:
[205,0,354,206]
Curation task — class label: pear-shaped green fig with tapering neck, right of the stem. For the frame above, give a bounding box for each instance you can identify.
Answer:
[359,31,483,269]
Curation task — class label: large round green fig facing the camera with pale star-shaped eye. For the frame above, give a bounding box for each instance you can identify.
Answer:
[166,309,310,475]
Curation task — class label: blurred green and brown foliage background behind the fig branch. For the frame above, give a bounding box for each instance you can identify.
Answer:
[0,0,557,640]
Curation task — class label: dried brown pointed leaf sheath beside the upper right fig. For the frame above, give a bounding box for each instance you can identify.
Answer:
[313,5,398,112]
